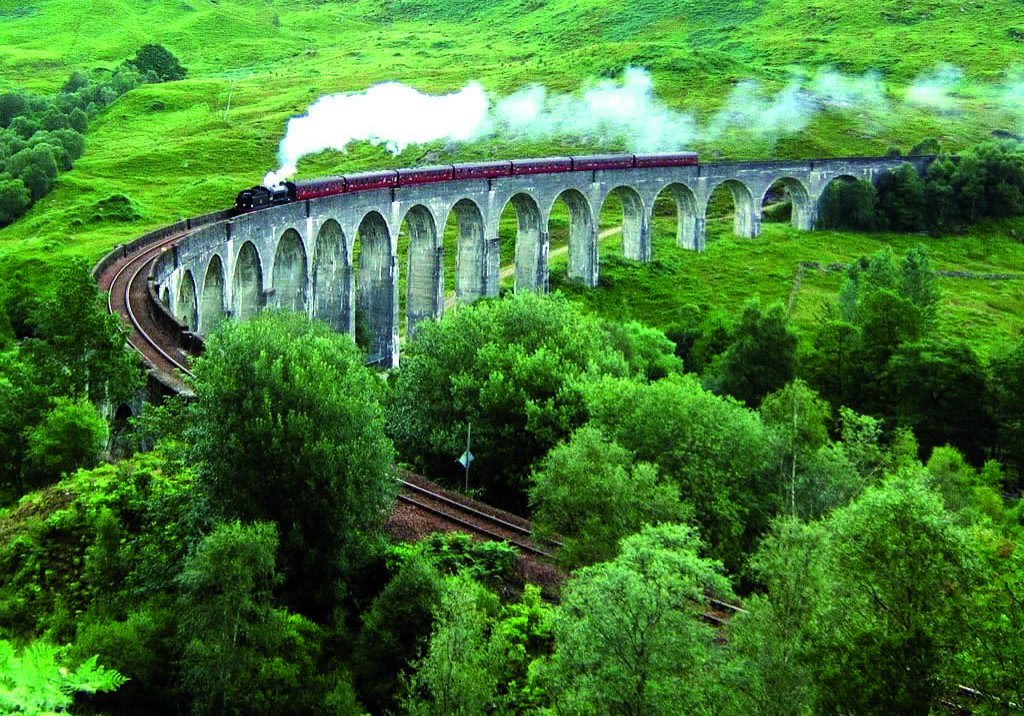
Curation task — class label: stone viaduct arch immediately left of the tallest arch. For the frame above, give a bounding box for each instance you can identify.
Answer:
[312,219,353,333]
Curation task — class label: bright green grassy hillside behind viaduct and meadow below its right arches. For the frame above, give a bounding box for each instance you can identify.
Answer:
[0,0,1024,344]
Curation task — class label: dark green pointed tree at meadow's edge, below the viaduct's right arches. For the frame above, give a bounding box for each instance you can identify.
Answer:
[708,299,797,408]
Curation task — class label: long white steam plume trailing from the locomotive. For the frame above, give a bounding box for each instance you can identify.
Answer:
[264,65,1024,185]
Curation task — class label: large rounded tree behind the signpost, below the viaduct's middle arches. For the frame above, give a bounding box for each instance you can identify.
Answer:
[389,293,622,511]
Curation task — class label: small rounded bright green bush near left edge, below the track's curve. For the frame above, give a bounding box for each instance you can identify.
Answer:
[22,396,110,491]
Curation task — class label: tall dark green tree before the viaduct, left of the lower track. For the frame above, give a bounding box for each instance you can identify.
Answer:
[185,311,396,618]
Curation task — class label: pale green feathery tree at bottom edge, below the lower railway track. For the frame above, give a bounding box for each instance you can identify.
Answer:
[546,524,729,716]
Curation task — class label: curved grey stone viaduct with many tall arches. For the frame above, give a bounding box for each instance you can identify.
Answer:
[155,157,931,366]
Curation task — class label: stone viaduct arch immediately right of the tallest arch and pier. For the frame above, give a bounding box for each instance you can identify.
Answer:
[403,204,444,336]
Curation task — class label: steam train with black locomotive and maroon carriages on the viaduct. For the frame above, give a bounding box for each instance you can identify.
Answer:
[234,152,697,213]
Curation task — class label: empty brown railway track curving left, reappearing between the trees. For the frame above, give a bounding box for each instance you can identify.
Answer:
[95,222,560,559]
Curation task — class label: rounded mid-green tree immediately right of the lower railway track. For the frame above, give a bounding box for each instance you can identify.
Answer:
[529,425,689,570]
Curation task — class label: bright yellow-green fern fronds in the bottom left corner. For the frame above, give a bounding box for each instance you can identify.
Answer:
[0,640,125,716]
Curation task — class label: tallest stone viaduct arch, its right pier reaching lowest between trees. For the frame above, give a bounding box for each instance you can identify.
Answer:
[356,211,397,365]
